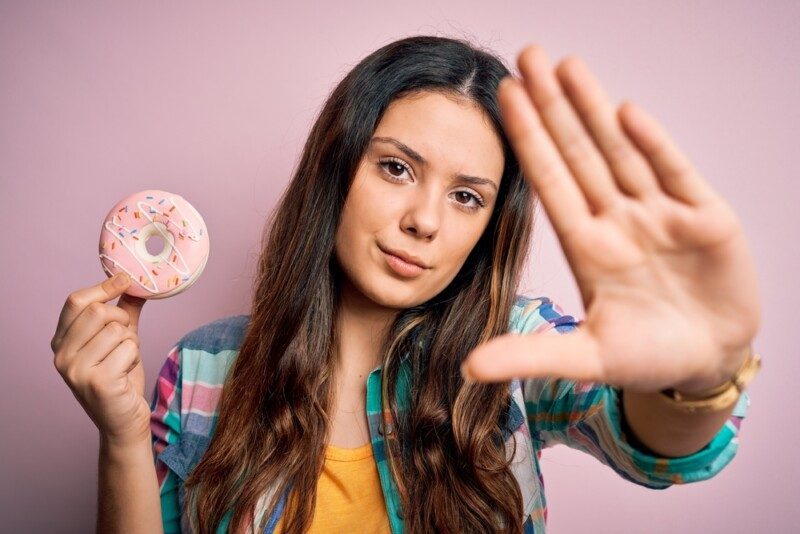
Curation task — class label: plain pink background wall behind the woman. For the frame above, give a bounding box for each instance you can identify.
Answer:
[0,0,800,533]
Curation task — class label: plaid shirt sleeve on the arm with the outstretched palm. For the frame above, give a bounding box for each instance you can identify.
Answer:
[520,297,750,489]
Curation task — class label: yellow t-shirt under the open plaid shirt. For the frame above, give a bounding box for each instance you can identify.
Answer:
[275,443,391,534]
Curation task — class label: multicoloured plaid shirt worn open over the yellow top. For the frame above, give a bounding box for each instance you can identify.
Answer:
[150,295,750,534]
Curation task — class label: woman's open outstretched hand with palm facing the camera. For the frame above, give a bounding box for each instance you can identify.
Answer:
[464,45,761,393]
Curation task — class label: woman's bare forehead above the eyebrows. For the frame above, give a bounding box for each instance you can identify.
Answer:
[373,91,503,185]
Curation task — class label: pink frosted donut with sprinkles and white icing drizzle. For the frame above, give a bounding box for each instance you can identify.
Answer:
[100,189,209,299]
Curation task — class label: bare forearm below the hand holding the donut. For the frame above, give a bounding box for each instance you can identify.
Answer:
[97,437,163,534]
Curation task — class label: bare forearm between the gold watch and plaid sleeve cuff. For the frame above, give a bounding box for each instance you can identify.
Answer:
[621,391,735,458]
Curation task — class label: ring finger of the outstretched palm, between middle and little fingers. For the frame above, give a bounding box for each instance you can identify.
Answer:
[556,57,661,201]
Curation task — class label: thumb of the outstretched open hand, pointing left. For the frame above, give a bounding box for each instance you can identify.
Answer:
[462,328,605,382]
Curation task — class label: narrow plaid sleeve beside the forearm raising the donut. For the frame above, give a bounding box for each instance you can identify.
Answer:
[150,345,181,534]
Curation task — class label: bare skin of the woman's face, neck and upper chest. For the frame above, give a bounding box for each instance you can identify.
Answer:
[331,92,504,447]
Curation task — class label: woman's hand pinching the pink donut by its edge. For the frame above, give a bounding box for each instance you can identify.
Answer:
[50,273,150,446]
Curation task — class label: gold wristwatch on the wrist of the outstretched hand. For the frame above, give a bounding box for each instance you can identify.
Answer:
[660,350,761,413]
